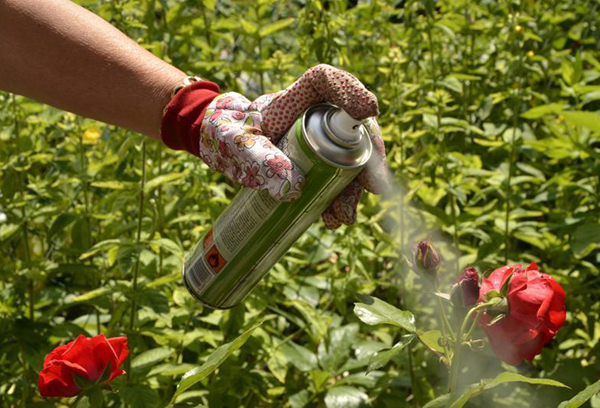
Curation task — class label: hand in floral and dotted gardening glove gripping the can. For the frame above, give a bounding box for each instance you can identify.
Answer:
[162,64,387,229]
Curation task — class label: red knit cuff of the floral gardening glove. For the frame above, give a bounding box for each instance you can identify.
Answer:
[160,81,219,157]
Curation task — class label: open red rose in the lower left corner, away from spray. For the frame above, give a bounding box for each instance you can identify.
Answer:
[39,334,129,397]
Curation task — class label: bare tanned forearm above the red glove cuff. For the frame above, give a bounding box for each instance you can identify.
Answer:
[0,0,185,139]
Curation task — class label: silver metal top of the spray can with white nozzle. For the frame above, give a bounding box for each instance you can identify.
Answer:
[302,103,373,169]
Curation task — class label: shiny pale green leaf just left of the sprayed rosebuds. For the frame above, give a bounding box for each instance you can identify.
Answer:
[354,295,416,333]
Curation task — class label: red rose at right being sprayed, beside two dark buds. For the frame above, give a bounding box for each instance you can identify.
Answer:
[479,262,566,365]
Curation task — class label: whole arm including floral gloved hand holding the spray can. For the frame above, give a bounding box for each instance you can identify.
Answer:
[0,0,385,228]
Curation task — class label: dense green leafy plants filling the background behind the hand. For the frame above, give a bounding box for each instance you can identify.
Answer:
[0,0,600,408]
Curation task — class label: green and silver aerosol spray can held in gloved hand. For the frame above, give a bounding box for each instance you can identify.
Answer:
[183,104,372,309]
